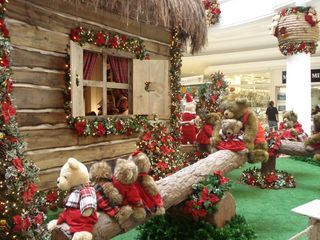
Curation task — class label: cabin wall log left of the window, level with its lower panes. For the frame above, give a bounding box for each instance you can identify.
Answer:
[13,87,64,109]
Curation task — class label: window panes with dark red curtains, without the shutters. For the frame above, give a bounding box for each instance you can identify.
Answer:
[83,50,132,116]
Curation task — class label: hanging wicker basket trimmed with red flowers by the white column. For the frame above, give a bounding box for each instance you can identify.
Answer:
[275,7,319,55]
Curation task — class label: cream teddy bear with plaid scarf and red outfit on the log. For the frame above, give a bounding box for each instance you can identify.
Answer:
[47,158,98,240]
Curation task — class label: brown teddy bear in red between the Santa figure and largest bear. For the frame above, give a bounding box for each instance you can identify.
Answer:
[197,113,221,153]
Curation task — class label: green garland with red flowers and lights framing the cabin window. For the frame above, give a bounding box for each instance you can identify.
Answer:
[64,27,148,137]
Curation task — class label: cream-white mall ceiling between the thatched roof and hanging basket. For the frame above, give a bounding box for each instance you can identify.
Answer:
[182,0,320,77]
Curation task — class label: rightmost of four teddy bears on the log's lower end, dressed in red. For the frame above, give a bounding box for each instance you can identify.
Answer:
[129,150,165,215]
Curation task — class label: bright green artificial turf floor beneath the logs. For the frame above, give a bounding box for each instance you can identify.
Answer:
[113,158,320,240]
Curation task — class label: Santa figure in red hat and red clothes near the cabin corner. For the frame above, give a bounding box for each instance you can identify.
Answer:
[181,93,199,144]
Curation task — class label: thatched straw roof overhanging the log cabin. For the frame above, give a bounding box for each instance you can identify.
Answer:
[65,0,207,53]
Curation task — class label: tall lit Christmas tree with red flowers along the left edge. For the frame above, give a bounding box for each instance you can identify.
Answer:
[0,0,45,240]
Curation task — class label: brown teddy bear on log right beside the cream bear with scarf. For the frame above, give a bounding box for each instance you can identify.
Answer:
[89,161,123,217]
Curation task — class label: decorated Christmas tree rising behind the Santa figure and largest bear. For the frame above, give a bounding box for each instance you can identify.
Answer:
[197,72,228,119]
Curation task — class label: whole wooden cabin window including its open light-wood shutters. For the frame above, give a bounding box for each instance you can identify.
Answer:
[70,41,170,118]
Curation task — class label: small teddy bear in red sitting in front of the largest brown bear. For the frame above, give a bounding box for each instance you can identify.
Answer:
[215,119,246,152]
